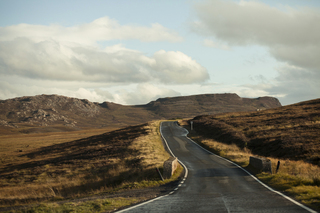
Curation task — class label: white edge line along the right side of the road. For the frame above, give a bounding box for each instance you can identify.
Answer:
[176,121,317,213]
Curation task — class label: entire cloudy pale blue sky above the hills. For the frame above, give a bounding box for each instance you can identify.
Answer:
[0,0,320,105]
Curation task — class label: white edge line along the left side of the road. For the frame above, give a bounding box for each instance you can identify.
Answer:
[116,122,188,213]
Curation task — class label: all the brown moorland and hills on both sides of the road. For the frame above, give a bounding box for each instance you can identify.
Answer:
[0,94,320,212]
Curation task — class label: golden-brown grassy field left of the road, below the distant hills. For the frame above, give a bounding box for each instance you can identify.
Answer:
[0,121,169,207]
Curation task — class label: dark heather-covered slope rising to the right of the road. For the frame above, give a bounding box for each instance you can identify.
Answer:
[193,99,320,165]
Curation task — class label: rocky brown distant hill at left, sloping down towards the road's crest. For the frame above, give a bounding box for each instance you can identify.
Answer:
[0,95,159,133]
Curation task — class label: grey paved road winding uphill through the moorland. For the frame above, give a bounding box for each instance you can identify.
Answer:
[116,122,310,213]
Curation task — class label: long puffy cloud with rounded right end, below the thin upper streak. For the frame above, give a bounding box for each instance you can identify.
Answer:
[0,38,209,84]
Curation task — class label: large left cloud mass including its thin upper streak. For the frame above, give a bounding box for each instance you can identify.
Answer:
[0,17,208,84]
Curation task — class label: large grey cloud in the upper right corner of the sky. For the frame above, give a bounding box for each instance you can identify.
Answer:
[193,0,320,70]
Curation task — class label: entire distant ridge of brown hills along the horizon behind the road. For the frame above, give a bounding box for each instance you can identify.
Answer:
[0,93,281,133]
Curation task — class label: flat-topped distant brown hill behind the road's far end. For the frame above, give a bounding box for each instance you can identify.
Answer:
[145,93,281,118]
